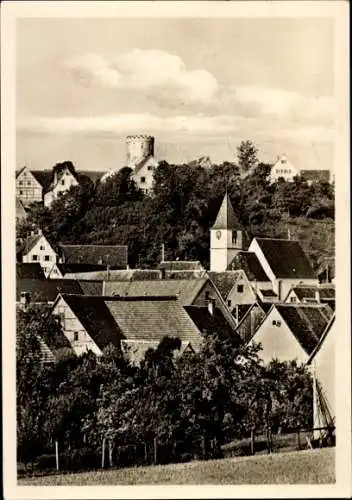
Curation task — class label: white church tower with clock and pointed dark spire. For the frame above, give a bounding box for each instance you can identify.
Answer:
[210,193,247,272]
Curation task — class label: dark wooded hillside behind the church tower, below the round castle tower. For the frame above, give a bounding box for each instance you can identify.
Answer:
[17,141,334,267]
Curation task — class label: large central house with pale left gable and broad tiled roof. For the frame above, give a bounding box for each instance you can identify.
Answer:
[52,294,206,363]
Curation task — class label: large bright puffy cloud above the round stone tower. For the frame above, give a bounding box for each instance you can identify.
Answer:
[63,49,218,103]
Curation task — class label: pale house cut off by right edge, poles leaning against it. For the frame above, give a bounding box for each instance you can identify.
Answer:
[307,315,336,438]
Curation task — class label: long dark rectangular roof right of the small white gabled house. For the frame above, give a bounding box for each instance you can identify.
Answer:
[60,245,127,268]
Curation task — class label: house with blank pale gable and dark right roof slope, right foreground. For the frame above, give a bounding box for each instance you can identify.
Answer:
[250,304,333,363]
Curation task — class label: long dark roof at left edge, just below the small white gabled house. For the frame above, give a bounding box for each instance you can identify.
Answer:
[16,278,83,303]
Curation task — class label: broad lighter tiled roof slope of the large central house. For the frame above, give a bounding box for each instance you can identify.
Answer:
[105,296,202,349]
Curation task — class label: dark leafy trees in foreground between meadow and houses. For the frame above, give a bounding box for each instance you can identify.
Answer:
[17,304,312,467]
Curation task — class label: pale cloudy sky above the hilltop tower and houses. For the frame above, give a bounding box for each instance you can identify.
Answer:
[16,17,335,170]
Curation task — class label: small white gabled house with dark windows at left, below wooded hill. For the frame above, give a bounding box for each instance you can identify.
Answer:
[18,231,58,276]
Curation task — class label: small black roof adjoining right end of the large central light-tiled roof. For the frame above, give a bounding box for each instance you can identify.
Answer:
[184,306,240,343]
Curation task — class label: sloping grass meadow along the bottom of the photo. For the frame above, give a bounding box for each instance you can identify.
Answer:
[18,448,335,486]
